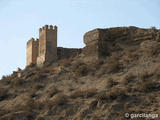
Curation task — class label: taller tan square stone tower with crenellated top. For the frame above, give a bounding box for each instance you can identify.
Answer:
[37,25,57,65]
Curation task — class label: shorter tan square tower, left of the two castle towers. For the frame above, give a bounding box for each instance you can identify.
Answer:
[27,38,39,66]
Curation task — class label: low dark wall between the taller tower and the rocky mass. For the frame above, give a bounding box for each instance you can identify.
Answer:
[57,47,81,59]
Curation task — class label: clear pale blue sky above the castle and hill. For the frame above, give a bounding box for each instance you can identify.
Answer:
[0,0,160,77]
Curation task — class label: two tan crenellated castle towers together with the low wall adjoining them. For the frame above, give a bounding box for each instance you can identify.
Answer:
[26,25,81,66]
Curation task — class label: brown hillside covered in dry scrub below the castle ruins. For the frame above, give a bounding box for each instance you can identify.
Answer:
[0,28,160,120]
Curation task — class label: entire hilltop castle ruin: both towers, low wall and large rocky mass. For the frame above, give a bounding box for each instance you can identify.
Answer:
[27,25,160,66]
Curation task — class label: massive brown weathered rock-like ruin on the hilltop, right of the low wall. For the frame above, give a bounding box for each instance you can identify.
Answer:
[83,26,160,58]
